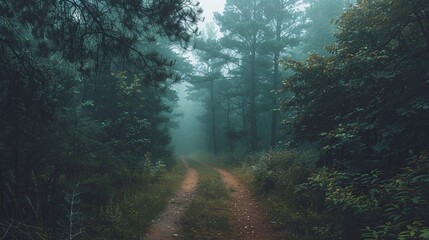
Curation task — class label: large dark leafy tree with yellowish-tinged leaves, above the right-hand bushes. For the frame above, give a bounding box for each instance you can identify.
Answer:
[284,0,429,172]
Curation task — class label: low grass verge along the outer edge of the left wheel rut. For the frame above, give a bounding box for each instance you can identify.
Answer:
[86,158,186,239]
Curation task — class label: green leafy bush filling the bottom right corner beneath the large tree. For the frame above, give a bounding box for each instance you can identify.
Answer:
[297,154,429,239]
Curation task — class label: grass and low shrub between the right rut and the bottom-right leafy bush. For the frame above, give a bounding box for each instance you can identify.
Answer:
[233,151,331,240]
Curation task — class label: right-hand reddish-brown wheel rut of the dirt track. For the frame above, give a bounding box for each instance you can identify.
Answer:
[215,168,278,240]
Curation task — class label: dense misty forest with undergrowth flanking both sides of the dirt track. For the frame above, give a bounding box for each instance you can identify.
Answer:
[0,0,429,240]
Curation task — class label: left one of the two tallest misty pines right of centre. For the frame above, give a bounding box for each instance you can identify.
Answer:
[215,0,267,151]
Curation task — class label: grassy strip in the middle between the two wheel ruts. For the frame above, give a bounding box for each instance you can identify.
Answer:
[180,161,233,240]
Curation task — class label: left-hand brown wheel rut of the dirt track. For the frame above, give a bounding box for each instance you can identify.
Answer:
[145,158,198,240]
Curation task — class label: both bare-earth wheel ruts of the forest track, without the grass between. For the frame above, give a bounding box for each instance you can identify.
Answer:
[145,158,283,240]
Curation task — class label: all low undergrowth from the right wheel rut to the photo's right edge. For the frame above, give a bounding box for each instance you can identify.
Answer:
[234,151,429,240]
